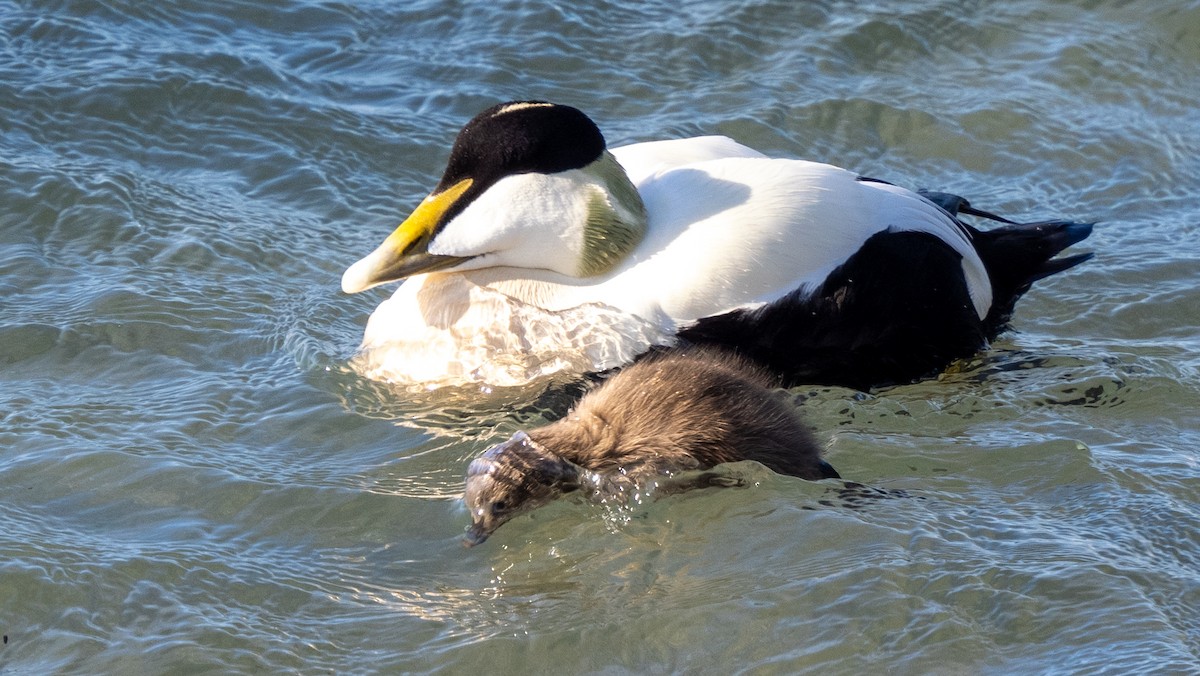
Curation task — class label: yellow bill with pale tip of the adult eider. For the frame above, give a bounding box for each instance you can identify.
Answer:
[342,179,474,293]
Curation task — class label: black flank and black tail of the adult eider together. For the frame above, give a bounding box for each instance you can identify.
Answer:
[679,187,1092,389]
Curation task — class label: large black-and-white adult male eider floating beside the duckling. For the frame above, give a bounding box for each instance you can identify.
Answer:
[342,101,1092,388]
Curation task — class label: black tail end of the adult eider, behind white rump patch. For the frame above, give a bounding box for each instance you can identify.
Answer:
[920,191,1094,340]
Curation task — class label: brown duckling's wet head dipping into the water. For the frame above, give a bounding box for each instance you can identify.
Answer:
[463,432,580,546]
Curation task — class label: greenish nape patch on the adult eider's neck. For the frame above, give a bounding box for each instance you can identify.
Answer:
[578,150,647,277]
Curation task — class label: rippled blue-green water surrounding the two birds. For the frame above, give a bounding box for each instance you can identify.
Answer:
[0,0,1200,674]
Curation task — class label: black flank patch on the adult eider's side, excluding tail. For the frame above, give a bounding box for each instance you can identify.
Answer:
[679,231,988,390]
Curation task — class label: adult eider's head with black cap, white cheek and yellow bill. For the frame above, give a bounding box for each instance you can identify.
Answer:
[342,101,647,293]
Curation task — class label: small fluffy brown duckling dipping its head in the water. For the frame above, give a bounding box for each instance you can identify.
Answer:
[463,349,839,546]
